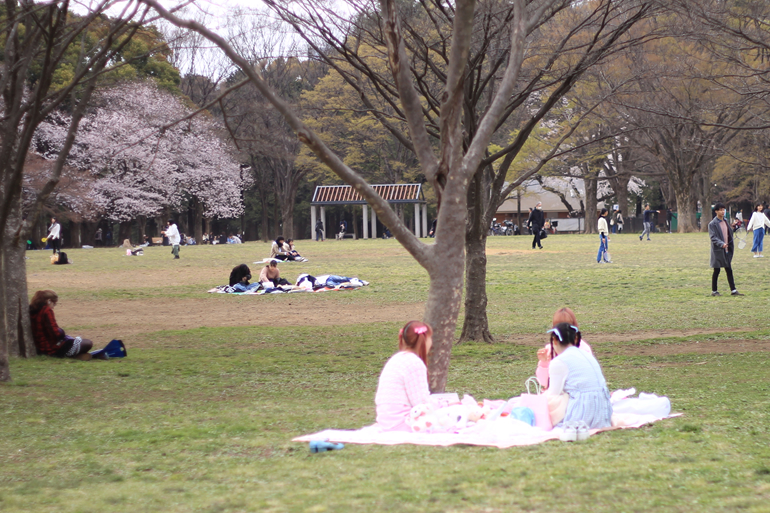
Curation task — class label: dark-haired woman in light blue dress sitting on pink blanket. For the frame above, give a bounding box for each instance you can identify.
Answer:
[545,322,612,429]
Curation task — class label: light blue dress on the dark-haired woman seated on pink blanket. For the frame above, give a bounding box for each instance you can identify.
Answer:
[558,346,612,429]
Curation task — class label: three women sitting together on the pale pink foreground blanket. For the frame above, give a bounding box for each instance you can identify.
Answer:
[374,308,612,431]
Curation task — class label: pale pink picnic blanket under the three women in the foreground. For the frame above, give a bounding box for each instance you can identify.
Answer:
[292,389,682,449]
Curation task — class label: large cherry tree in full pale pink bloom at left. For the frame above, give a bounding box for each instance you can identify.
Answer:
[34,80,248,237]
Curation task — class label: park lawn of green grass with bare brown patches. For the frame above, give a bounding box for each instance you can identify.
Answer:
[0,234,770,513]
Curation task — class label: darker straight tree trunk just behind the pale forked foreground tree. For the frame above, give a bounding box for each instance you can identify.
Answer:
[458,173,494,344]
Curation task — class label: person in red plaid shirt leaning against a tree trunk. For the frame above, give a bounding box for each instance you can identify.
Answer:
[29,290,94,360]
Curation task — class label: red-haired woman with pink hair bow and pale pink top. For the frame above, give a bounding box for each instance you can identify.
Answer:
[374,321,433,431]
